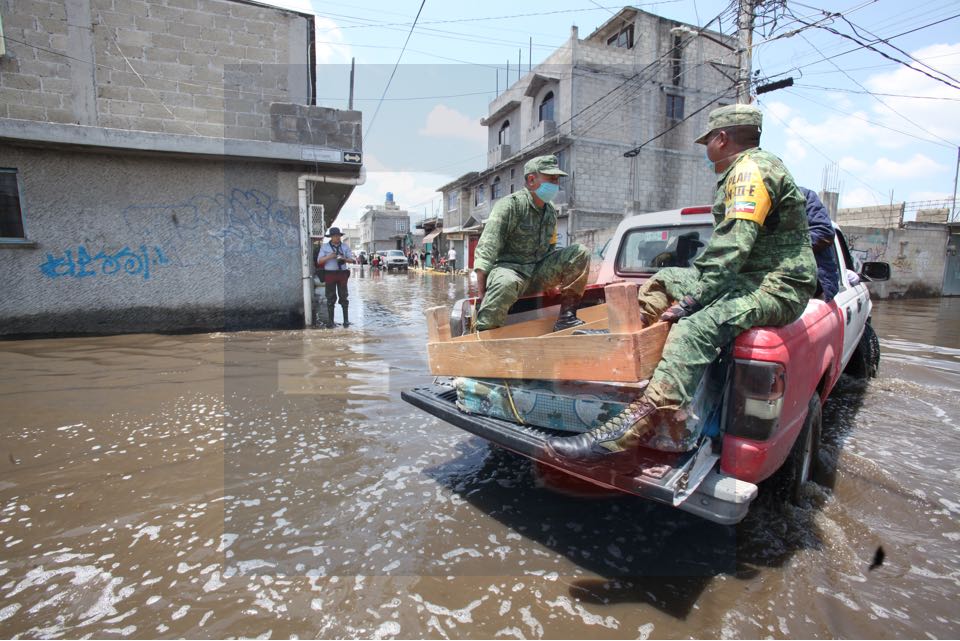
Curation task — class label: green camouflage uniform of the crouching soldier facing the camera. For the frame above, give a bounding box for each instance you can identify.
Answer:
[474,189,590,331]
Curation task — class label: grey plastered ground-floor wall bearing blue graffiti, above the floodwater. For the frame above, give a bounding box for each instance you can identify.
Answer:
[0,147,303,335]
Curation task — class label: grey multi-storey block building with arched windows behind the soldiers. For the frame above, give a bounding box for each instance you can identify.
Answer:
[439,7,736,264]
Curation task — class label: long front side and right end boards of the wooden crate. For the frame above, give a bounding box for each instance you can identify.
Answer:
[427,319,670,383]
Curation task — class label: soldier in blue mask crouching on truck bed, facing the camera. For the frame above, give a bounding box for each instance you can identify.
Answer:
[474,156,590,331]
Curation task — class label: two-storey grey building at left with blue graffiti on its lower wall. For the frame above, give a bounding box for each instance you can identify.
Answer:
[0,0,363,335]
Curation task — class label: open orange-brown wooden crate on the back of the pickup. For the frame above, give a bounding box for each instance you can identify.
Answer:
[427,283,670,383]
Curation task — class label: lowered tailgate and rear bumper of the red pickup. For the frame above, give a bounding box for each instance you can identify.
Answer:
[400,385,744,522]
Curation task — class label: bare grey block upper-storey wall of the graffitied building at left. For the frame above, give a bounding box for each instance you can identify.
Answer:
[0,0,346,144]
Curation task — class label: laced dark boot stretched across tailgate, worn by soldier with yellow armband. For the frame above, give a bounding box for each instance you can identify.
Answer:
[546,398,657,461]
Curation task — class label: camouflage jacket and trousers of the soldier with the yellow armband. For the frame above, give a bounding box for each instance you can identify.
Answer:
[639,147,817,407]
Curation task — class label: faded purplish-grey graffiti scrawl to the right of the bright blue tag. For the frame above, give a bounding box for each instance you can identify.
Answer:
[123,189,300,267]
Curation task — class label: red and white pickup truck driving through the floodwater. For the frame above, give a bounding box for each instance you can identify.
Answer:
[401,207,890,523]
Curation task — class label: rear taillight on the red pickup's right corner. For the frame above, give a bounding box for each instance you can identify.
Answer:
[727,360,786,441]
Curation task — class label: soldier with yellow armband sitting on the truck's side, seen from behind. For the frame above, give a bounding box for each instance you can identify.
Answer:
[547,105,817,460]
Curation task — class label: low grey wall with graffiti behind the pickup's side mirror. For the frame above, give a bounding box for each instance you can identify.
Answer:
[843,225,949,298]
